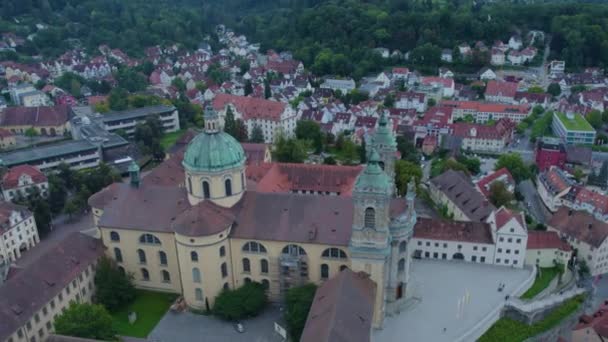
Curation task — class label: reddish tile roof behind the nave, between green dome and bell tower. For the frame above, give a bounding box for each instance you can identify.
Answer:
[256,163,363,195]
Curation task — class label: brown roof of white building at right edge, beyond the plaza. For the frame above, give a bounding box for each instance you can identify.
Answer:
[548,207,608,247]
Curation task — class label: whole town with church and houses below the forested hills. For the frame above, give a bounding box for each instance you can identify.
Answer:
[0,19,608,342]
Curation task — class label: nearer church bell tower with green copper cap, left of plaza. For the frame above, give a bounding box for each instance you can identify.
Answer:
[349,149,392,328]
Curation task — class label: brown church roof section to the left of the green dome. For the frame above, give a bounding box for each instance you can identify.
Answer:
[99,183,190,232]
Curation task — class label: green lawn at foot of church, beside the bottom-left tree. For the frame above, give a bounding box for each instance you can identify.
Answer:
[112,290,177,337]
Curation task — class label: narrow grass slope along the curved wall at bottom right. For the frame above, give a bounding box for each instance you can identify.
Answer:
[477,295,585,342]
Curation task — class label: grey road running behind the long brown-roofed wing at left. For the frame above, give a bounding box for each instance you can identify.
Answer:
[16,212,94,267]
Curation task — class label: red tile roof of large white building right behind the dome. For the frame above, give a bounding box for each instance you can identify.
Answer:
[213,93,287,121]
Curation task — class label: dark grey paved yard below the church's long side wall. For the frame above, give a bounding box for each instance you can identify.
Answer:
[148,307,283,342]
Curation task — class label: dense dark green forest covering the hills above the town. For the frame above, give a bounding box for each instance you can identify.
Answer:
[0,0,608,77]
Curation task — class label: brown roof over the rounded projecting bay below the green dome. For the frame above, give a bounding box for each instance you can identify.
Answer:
[172,201,235,236]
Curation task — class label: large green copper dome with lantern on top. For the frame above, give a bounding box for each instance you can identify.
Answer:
[182,109,245,172]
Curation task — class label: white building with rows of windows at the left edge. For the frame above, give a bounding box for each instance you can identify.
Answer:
[0,201,40,264]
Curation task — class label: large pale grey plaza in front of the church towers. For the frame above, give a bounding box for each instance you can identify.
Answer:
[372,260,531,342]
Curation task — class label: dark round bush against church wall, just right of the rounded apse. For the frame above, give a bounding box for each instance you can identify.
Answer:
[213,282,268,321]
